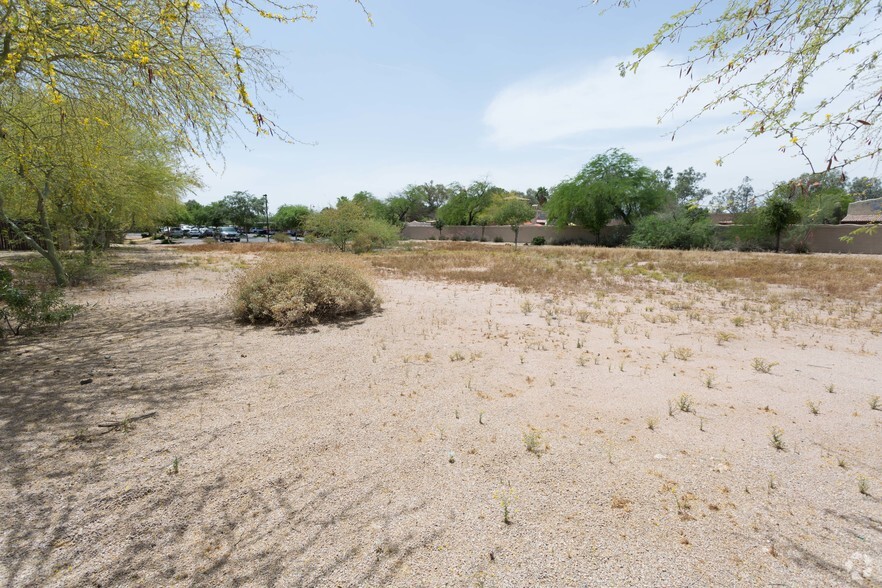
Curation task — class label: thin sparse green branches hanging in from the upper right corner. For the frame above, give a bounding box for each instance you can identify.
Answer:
[594,0,882,173]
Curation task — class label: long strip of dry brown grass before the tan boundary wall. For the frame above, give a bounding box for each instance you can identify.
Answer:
[371,243,882,300]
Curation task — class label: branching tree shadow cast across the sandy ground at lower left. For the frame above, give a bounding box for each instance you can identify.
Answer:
[0,258,436,586]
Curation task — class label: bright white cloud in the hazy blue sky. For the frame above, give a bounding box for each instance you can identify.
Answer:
[484,55,685,148]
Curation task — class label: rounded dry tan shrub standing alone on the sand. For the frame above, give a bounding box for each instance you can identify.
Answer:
[230,253,381,326]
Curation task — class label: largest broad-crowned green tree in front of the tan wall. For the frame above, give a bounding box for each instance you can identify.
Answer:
[546,149,669,244]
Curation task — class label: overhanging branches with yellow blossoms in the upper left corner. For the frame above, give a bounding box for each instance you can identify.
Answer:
[0,0,369,151]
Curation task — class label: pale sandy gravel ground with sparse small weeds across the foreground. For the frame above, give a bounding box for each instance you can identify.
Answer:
[0,249,882,587]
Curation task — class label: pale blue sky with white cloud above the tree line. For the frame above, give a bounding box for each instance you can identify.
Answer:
[195,0,874,209]
